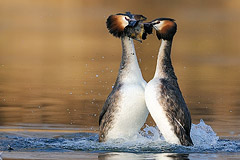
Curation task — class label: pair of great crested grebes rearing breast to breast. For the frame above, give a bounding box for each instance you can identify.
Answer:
[99,12,193,146]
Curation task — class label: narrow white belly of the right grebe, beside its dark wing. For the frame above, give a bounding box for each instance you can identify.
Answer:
[145,79,181,144]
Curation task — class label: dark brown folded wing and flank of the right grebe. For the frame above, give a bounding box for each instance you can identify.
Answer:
[159,79,193,146]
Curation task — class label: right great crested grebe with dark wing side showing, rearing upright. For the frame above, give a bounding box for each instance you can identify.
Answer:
[145,18,193,146]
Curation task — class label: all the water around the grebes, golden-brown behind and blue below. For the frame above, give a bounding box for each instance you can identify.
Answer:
[0,0,240,159]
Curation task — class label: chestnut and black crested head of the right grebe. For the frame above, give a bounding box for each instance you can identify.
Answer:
[151,18,177,40]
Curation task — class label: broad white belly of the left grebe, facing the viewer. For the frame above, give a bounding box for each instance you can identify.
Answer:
[107,84,149,139]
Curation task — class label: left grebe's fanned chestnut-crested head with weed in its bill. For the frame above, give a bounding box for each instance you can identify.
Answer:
[106,12,147,41]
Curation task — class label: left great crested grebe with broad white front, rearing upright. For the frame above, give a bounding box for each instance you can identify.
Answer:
[99,12,149,142]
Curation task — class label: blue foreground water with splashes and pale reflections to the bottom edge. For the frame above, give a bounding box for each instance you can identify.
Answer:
[0,120,240,159]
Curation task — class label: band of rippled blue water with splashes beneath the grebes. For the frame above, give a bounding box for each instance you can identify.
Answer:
[0,120,240,153]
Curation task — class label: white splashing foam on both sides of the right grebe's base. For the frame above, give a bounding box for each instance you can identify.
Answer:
[101,119,219,149]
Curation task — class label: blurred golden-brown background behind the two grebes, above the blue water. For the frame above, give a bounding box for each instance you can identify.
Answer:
[0,0,240,137]
